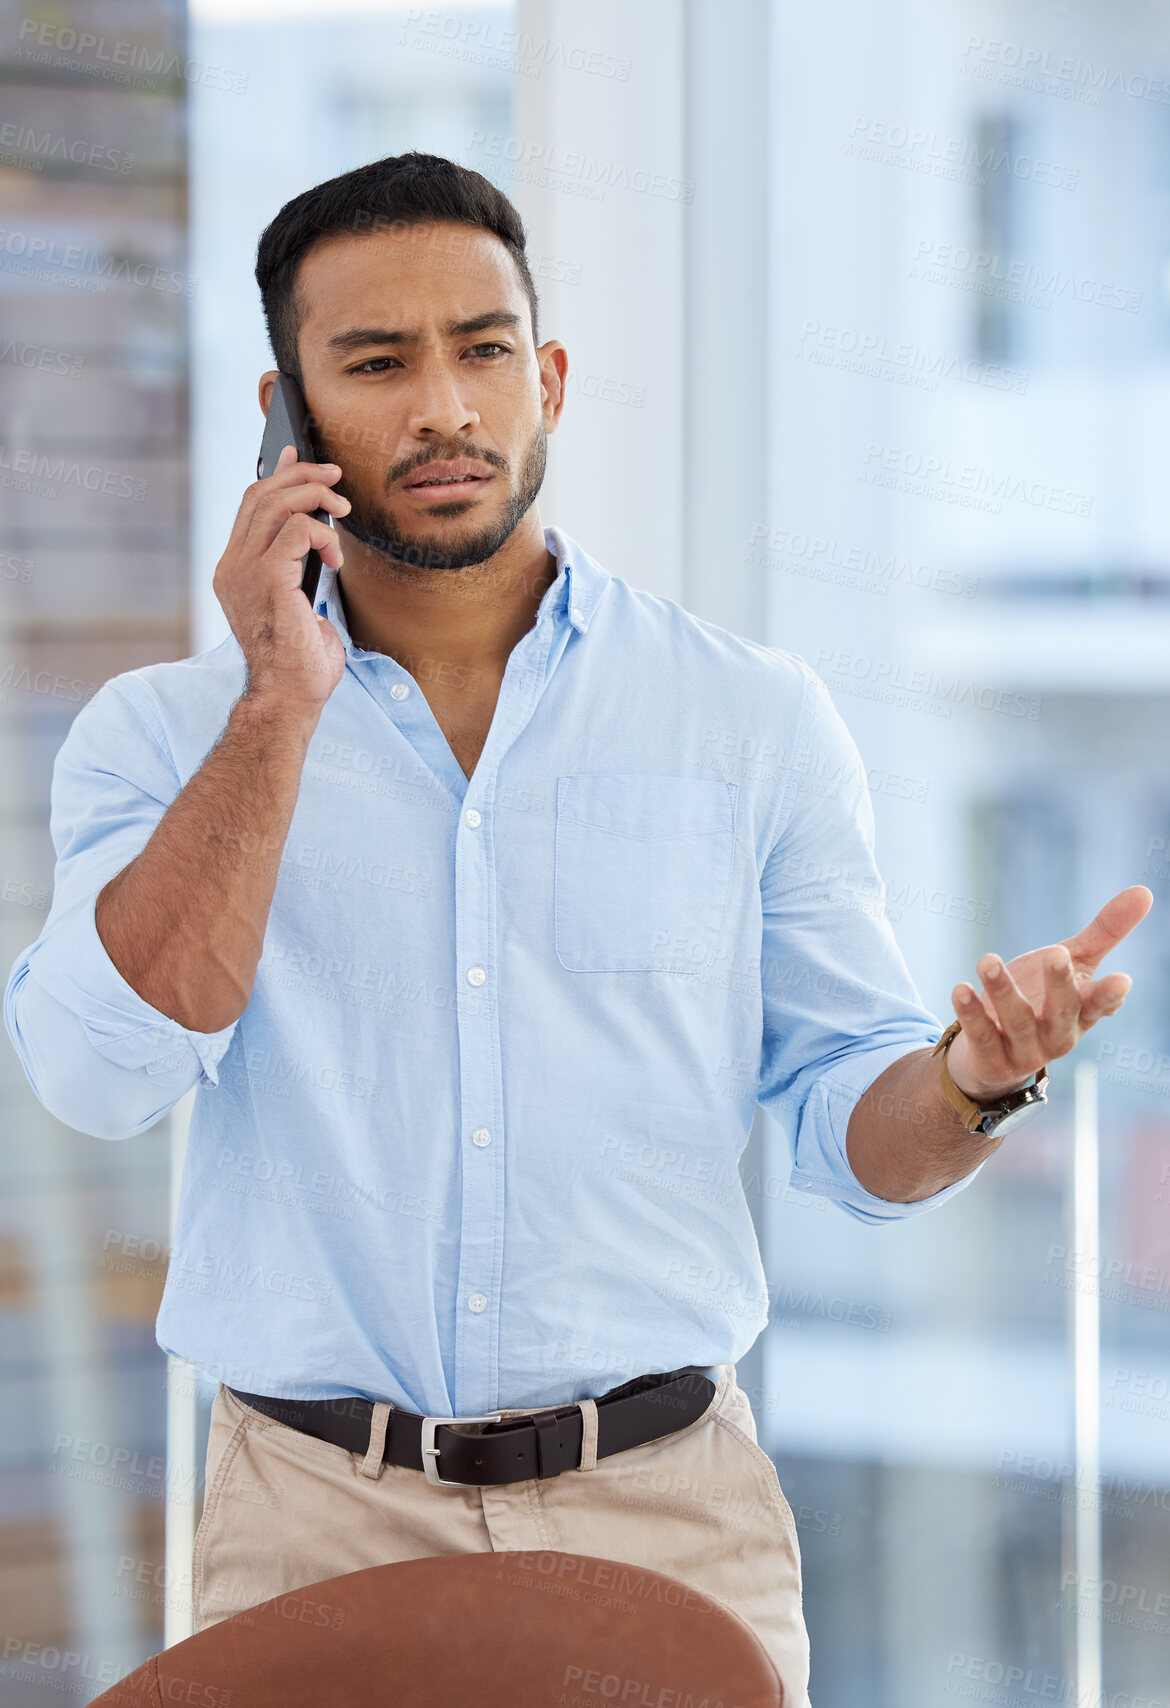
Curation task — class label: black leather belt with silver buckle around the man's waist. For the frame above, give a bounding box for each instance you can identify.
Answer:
[227,1365,716,1488]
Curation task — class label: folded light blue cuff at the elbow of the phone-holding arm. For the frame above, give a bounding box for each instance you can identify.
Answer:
[27,897,239,1085]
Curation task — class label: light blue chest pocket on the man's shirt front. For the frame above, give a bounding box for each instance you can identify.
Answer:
[555,772,738,972]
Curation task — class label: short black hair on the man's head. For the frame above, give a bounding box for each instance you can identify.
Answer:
[256,152,536,379]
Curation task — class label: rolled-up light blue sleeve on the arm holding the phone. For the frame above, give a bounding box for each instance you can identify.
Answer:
[3,676,237,1139]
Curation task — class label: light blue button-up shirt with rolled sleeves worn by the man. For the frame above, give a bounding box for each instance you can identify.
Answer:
[5,528,977,1416]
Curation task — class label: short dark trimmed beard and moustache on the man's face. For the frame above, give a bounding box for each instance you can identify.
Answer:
[321,420,548,569]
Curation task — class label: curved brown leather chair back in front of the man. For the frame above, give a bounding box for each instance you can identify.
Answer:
[91,1549,784,1708]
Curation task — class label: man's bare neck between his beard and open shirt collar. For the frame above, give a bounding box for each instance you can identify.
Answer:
[336,504,557,676]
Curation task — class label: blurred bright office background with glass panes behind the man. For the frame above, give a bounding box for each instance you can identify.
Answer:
[0,0,1170,1708]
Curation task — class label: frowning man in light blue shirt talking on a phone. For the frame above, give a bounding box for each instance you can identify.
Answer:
[5,154,1153,1708]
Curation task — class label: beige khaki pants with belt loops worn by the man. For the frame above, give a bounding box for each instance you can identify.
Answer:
[191,1365,808,1708]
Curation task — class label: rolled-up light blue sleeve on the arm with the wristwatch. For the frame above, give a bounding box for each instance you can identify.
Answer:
[758,659,982,1221]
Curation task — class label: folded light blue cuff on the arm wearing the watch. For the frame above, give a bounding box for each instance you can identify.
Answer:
[789,1027,986,1221]
